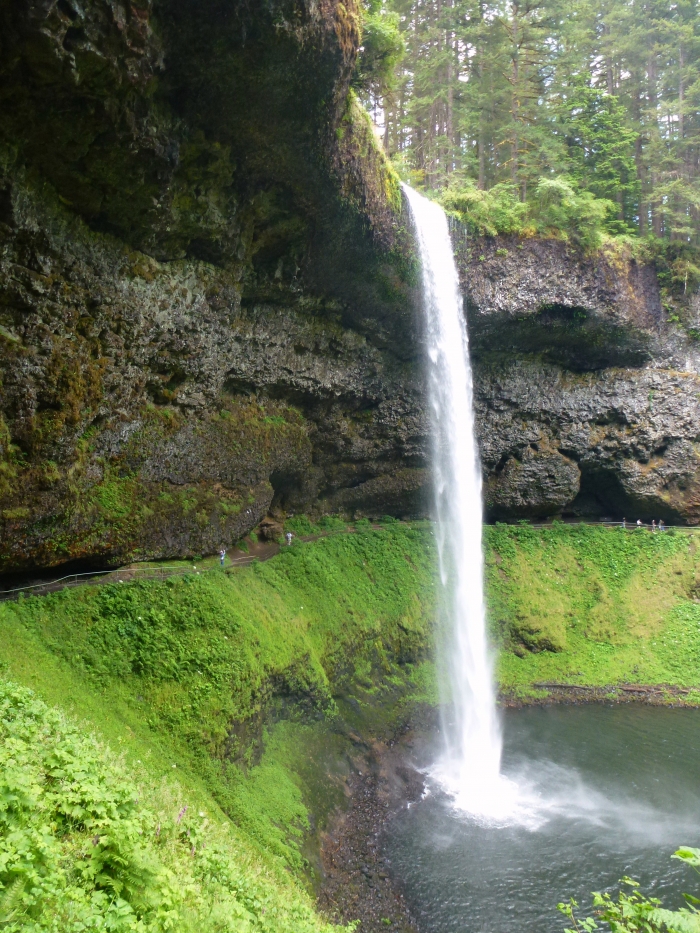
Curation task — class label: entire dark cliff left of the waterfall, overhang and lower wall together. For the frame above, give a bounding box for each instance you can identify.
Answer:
[0,0,425,571]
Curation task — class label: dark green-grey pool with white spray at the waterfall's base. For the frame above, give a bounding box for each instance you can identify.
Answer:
[383,704,700,933]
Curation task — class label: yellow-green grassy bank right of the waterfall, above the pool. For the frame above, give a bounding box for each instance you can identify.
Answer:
[486,524,700,703]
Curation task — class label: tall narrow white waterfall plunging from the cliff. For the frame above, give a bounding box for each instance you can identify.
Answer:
[404,186,510,818]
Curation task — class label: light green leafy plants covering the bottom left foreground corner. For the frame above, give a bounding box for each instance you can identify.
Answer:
[0,682,350,933]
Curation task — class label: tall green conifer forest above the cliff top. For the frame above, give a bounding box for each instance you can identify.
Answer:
[356,0,700,245]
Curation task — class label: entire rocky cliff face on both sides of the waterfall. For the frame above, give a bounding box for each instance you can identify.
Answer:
[0,0,700,572]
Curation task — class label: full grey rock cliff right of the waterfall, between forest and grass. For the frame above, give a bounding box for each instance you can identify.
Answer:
[456,234,700,523]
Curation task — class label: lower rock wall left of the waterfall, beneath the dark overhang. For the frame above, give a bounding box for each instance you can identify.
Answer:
[0,167,426,566]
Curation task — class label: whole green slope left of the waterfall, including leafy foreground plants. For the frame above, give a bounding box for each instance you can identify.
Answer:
[0,525,433,933]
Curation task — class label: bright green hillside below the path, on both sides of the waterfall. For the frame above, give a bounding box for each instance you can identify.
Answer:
[0,519,700,933]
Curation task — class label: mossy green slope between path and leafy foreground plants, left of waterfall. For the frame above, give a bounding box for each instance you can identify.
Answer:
[0,525,433,871]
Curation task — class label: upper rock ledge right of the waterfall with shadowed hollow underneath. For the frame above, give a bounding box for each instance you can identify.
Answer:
[455,232,664,371]
